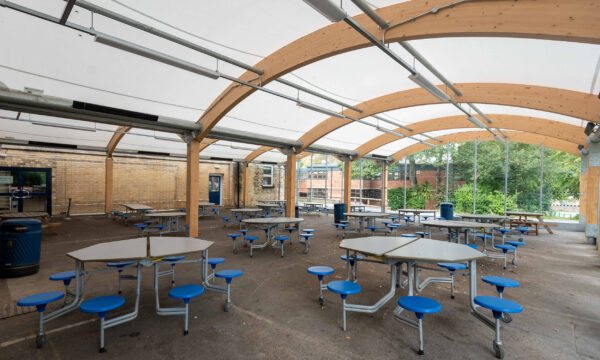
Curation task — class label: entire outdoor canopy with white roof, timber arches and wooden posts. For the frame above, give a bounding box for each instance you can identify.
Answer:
[0,0,600,236]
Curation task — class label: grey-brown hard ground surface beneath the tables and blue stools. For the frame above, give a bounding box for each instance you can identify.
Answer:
[0,215,600,360]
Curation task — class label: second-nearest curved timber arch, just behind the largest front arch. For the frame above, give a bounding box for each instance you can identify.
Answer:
[246,83,600,161]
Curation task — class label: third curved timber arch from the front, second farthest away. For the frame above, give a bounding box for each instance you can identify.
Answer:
[356,114,586,158]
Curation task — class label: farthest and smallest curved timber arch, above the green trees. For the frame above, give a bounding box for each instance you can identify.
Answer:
[392,130,579,161]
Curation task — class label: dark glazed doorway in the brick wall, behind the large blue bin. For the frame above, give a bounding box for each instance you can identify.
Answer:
[0,167,52,215]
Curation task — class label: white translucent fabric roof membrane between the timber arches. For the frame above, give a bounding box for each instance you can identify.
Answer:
[0,0,600,161]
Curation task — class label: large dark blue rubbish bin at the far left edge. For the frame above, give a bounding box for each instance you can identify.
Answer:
[0,219,42,277]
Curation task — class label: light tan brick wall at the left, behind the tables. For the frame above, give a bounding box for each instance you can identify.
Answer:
[0,148,237,215]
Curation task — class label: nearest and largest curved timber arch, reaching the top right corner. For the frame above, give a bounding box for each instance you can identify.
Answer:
[198,0,600,143]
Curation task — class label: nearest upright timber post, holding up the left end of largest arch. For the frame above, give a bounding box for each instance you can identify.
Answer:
[185,140,200,237]
